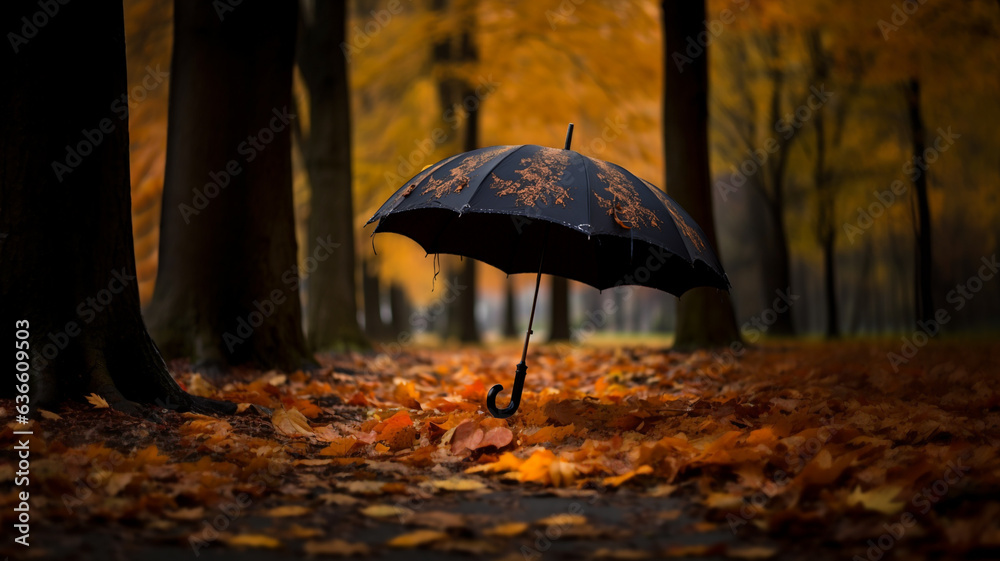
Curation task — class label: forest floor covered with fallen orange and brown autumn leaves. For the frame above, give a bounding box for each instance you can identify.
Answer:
[0,339,1000,561]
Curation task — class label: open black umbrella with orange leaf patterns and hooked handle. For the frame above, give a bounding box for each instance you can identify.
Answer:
[368,124,729,418]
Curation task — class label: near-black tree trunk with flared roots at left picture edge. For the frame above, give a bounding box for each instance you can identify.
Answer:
[0,0,236,414]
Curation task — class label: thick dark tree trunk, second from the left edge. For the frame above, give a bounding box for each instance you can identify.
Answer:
[148,0,313,371]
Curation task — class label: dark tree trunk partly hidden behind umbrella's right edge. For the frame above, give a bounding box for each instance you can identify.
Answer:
[662,0,740,348]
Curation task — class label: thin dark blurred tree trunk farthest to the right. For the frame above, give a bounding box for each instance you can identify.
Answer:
[906,76,934,322]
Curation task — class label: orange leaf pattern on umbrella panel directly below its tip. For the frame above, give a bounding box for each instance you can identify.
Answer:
[493,148,573,206]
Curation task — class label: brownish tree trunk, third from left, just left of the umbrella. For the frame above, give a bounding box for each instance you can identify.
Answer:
[298,2,368,350]
